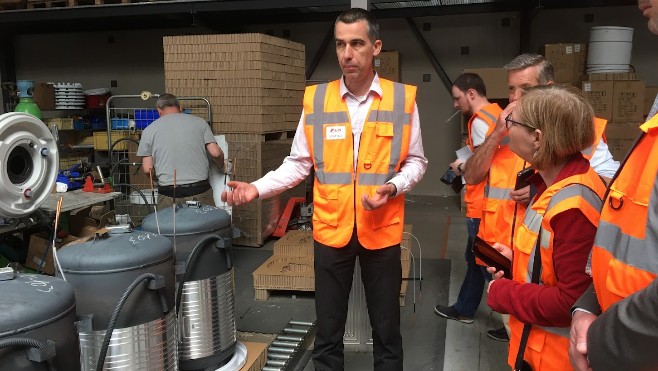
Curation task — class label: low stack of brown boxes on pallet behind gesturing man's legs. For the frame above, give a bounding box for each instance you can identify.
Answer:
[253,225,412,306]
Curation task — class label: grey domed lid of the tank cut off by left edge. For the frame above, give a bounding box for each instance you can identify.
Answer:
[0,273,75,338]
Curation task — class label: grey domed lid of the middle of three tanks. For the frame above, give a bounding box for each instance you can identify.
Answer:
[57,231,173,273]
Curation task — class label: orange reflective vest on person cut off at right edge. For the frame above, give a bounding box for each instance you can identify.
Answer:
[591,115,658,310]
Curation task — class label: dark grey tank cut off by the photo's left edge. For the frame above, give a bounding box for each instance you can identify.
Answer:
[0,268,80,371]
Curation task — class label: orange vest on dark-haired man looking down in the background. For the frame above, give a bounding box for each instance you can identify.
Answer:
[464,103,503,219]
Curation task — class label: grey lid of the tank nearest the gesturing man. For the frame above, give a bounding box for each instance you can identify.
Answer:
[142,202,231,236]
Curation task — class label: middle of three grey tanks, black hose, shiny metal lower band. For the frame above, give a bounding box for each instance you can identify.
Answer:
[58,229,178,371]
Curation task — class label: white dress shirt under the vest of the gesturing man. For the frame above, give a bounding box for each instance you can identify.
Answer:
[252,74,427,198]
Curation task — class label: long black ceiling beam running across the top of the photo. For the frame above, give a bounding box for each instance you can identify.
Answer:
[0,0,636,34]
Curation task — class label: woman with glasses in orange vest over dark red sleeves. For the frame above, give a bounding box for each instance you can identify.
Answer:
[487,85,605,370]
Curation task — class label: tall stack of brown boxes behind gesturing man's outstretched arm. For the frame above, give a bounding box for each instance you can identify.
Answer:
[163,34,306,246]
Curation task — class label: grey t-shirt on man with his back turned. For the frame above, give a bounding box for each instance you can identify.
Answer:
[137,113,216,186]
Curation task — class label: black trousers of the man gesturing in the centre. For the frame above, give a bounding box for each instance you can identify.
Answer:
[313,230,403,371]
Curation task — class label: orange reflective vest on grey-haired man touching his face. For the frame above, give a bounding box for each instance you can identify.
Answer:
[478,137,525,247]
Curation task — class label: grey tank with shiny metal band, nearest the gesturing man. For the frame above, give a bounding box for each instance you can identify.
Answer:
[142,202,236,370]
